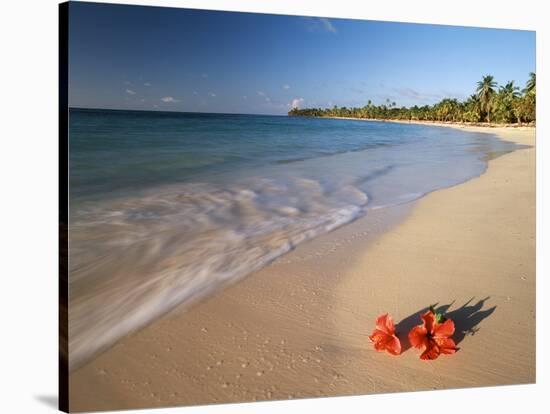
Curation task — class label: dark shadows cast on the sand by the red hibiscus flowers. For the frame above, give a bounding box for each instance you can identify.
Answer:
[395,297,496,352]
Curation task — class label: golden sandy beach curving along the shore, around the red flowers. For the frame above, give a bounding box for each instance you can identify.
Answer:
[70,127,535,411]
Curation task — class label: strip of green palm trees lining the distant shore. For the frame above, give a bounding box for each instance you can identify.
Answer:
[288,73,536,124]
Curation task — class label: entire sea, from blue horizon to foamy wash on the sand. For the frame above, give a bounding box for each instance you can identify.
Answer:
[69,109,517,366]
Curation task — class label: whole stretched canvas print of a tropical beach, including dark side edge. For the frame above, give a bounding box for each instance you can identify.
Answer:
[59,2,536,412]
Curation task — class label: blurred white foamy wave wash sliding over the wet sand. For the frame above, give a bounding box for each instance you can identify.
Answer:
[69,179,368,369]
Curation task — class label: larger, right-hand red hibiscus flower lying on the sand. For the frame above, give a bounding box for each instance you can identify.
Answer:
[409,309,456,360]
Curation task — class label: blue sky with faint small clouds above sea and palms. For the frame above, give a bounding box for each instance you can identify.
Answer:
[69,2,535,115]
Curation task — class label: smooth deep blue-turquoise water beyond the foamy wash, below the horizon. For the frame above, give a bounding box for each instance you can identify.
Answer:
[70,109,452,201]
